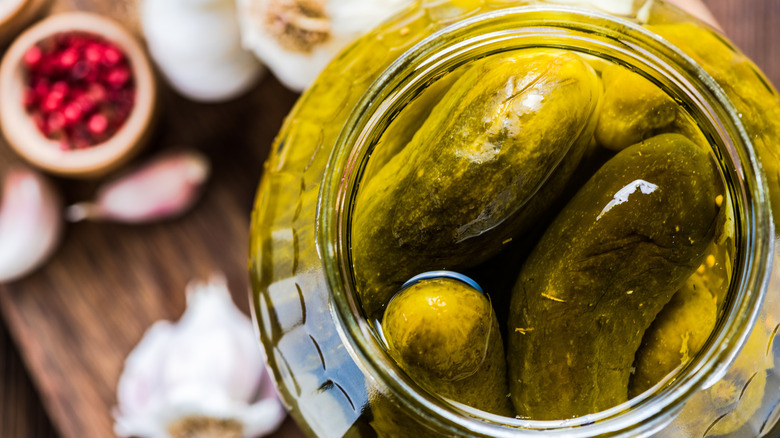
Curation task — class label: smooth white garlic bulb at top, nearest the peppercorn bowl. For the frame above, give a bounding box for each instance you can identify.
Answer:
[141,0,263,102]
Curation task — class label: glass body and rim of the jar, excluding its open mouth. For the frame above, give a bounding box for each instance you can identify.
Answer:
[250,0,780,437]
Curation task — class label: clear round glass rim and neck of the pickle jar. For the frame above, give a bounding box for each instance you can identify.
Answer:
[317,6,774,437]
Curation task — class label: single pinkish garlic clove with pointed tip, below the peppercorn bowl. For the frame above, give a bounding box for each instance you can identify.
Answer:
[65,151,211,223]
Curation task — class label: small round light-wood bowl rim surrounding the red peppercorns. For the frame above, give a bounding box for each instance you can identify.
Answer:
[0,12,157,178]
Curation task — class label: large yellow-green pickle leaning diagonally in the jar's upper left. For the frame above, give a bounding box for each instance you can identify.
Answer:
[352,50,601,314]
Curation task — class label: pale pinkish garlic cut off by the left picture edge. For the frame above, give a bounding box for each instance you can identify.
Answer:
[0,168,63,283]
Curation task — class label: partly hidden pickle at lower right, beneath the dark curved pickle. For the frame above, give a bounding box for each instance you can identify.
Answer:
[628,274,718,398]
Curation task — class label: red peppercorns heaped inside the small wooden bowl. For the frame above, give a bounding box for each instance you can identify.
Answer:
[24,32,135,150]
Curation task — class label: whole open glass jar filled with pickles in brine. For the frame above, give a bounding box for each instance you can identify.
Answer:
[250,0,780,437]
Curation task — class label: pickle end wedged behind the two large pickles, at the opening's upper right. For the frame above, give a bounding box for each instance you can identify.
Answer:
[596,65,678,151]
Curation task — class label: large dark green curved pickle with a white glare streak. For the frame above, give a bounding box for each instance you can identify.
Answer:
[507,134,723,420]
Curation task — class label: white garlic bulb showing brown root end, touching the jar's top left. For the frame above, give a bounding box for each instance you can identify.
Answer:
[238,0,413,91]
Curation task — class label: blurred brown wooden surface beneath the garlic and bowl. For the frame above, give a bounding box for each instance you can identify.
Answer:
[0,0,780,438]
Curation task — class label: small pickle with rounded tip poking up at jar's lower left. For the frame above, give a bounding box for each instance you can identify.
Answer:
[382,278,514,416]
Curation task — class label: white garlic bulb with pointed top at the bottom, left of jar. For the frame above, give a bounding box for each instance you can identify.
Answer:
[114,277,286,438]
